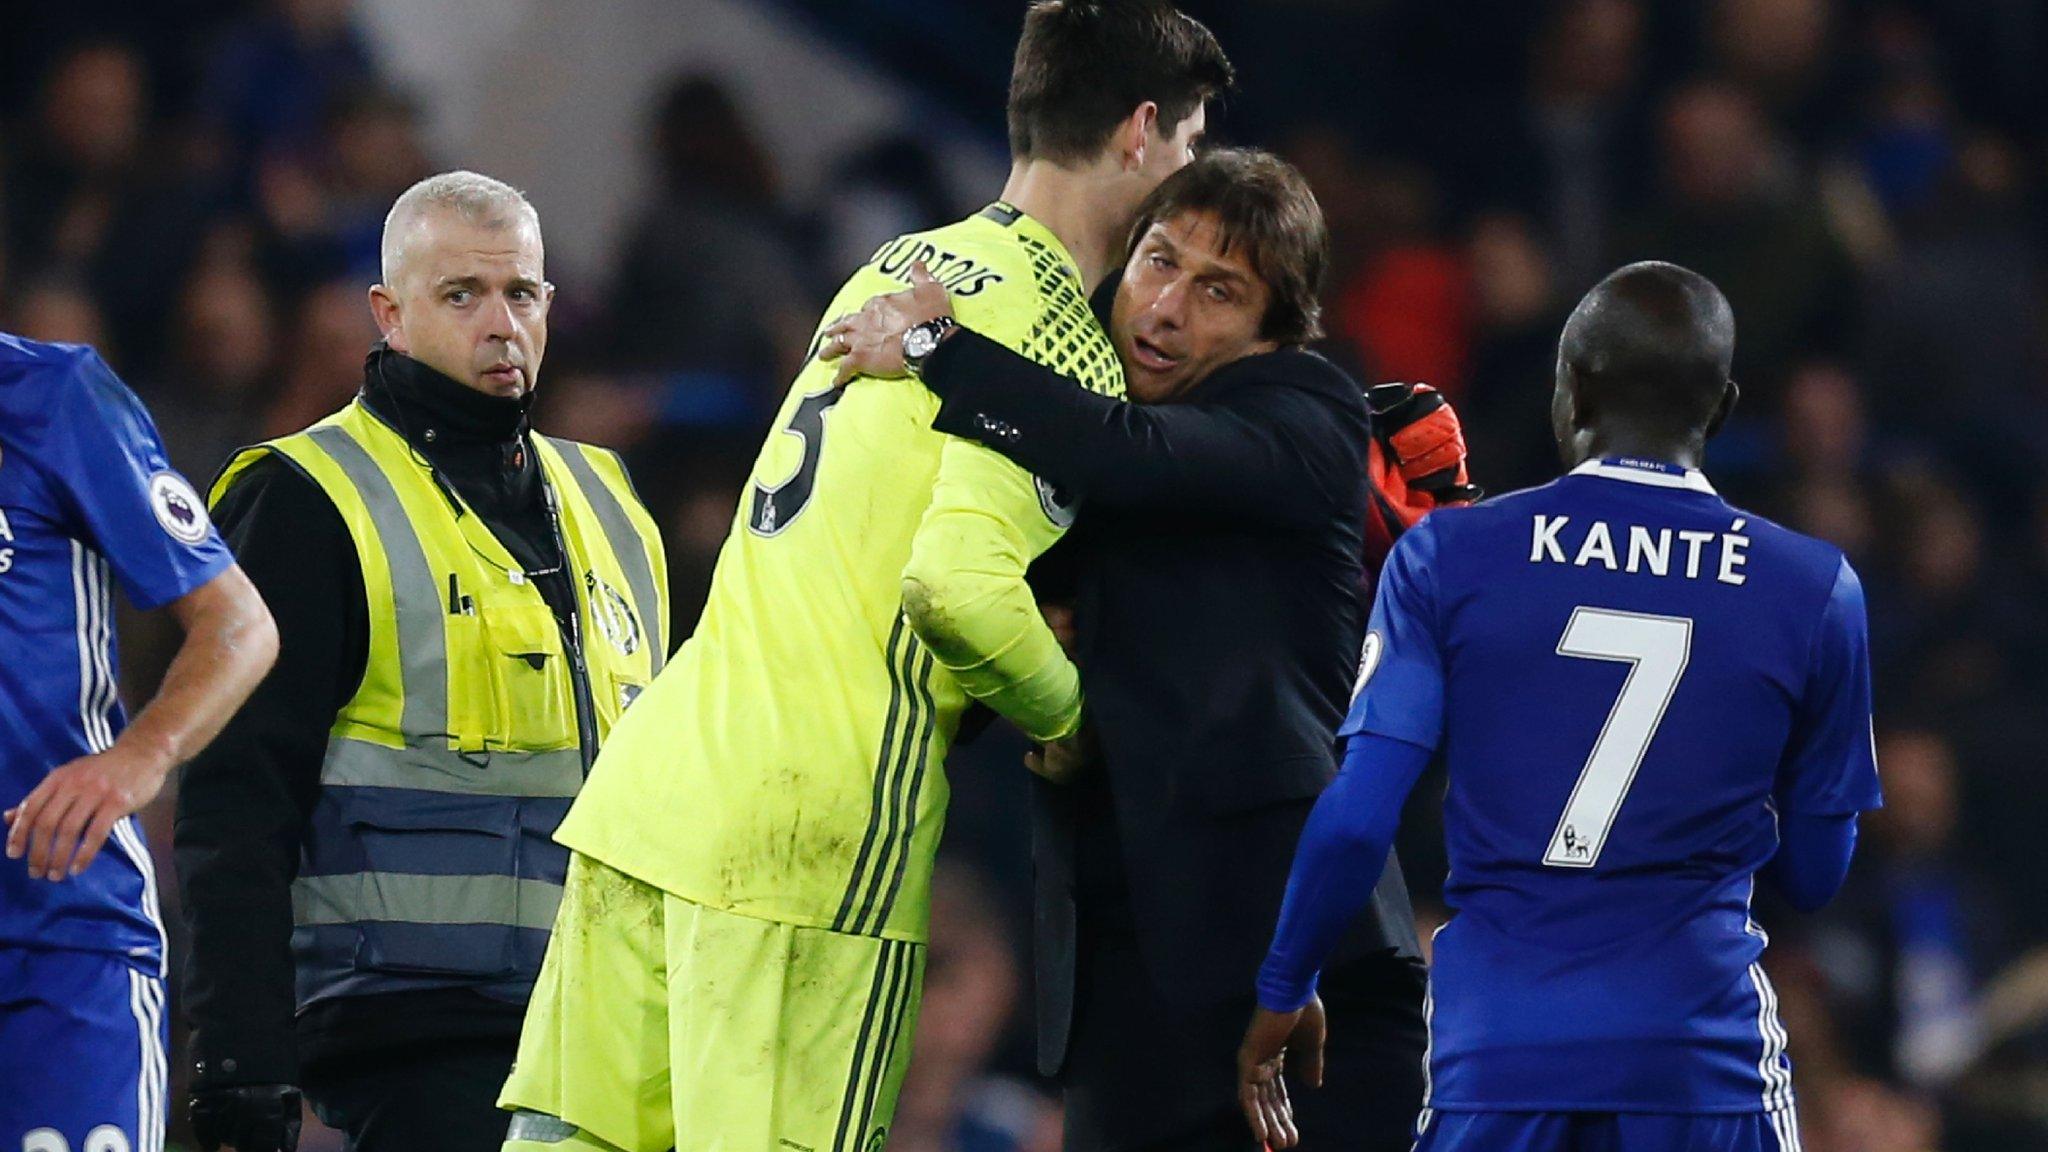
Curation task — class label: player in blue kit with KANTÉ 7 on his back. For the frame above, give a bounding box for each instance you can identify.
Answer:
[1239,264,1878,1152]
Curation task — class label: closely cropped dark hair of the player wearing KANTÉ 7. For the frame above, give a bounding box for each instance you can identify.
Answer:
[1556,260,1735,437]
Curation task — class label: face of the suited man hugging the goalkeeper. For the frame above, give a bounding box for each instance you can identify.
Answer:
[1110,211,1278,404]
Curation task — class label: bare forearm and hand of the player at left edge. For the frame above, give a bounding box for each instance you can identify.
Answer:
[6,566,276,881]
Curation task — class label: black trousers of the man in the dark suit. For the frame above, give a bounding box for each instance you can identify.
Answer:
[1061,910,1427,1152]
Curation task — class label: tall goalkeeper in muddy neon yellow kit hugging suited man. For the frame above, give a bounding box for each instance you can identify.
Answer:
[500,0,1231,1152]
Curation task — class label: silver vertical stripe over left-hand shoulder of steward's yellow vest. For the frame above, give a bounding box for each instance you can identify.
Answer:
[307,424,449,744]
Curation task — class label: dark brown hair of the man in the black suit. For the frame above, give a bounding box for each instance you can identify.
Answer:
[1130,148,1329,344]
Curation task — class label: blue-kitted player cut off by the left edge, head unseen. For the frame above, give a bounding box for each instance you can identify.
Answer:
[0,334,276,1152]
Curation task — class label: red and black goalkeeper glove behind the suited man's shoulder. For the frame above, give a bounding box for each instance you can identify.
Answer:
[1366,383,1485,572]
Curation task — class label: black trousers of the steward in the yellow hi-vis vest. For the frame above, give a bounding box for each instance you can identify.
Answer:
[305,1039,518,1152]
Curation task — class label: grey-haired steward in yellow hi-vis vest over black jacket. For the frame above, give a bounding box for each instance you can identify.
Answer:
[176,166,668,1152]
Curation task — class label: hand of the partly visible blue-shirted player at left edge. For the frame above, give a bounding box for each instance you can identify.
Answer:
[6,740,170,881]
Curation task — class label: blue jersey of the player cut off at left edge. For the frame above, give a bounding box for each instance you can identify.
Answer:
[0,334,233,974]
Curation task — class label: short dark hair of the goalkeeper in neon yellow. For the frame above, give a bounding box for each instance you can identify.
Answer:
[1010,0,1237,164]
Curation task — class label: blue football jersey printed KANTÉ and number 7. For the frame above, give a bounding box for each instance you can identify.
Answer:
[1343,459,1878,1113]
